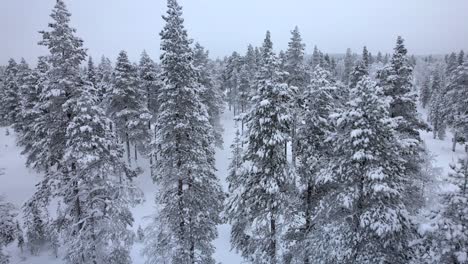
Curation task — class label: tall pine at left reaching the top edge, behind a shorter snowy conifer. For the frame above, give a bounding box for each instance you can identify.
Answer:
[25,0,86,172]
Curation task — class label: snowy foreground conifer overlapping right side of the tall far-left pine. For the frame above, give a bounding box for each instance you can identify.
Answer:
[56,82,140,264]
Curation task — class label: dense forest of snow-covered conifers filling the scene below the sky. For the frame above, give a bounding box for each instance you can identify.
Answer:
[0,0,468,264]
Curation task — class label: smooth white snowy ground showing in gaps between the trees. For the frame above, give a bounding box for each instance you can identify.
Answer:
[0,105,465,264]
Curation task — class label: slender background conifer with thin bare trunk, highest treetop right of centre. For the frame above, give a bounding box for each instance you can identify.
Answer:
[285,27,308,166]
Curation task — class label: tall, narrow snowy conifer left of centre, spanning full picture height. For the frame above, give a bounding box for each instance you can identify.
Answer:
[144,0,224,264]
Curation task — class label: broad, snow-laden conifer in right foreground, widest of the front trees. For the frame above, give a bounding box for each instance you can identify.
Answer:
[310,77,414,263]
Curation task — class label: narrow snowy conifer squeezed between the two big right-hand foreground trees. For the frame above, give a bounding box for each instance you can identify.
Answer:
[286,66,338,264]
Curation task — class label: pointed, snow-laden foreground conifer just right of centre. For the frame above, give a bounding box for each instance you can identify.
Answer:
[226,32,291,263]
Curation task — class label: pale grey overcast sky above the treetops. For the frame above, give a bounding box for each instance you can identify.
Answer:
[0,0,468,64]
